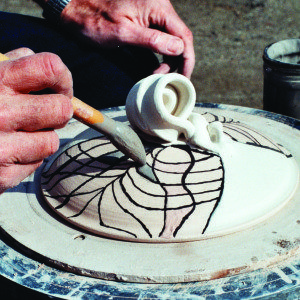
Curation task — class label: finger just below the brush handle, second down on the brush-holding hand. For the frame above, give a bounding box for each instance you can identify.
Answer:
[0,94,73,132]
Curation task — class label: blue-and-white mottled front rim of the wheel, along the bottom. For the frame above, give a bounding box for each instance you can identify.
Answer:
[0,231,300,300]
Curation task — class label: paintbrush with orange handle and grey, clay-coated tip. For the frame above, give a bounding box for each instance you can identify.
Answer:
[0,53,155,180]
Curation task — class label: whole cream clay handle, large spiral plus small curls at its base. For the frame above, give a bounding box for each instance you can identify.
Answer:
[126,73,229,152]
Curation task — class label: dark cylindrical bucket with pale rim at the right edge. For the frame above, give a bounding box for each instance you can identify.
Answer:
[263,39,300,119]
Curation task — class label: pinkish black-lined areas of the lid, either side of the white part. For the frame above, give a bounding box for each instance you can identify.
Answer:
[42,113,291,239]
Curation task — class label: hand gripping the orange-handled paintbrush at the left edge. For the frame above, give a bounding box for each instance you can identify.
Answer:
[0,49,73,193]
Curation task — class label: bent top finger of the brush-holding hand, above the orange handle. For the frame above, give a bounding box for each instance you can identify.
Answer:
[0,53,73,98]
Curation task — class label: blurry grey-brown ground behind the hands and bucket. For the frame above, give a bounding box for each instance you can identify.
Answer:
[0,0,300,108]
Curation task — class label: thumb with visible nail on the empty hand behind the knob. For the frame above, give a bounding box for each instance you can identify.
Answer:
[126,26,184,56]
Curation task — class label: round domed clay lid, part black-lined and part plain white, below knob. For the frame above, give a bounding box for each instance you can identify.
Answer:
[42,75,299,242]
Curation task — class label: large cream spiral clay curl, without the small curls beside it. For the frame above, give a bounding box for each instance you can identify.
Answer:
[126,73,196,142]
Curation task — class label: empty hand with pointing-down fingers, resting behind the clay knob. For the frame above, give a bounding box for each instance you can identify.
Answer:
[62,0,195,78]
